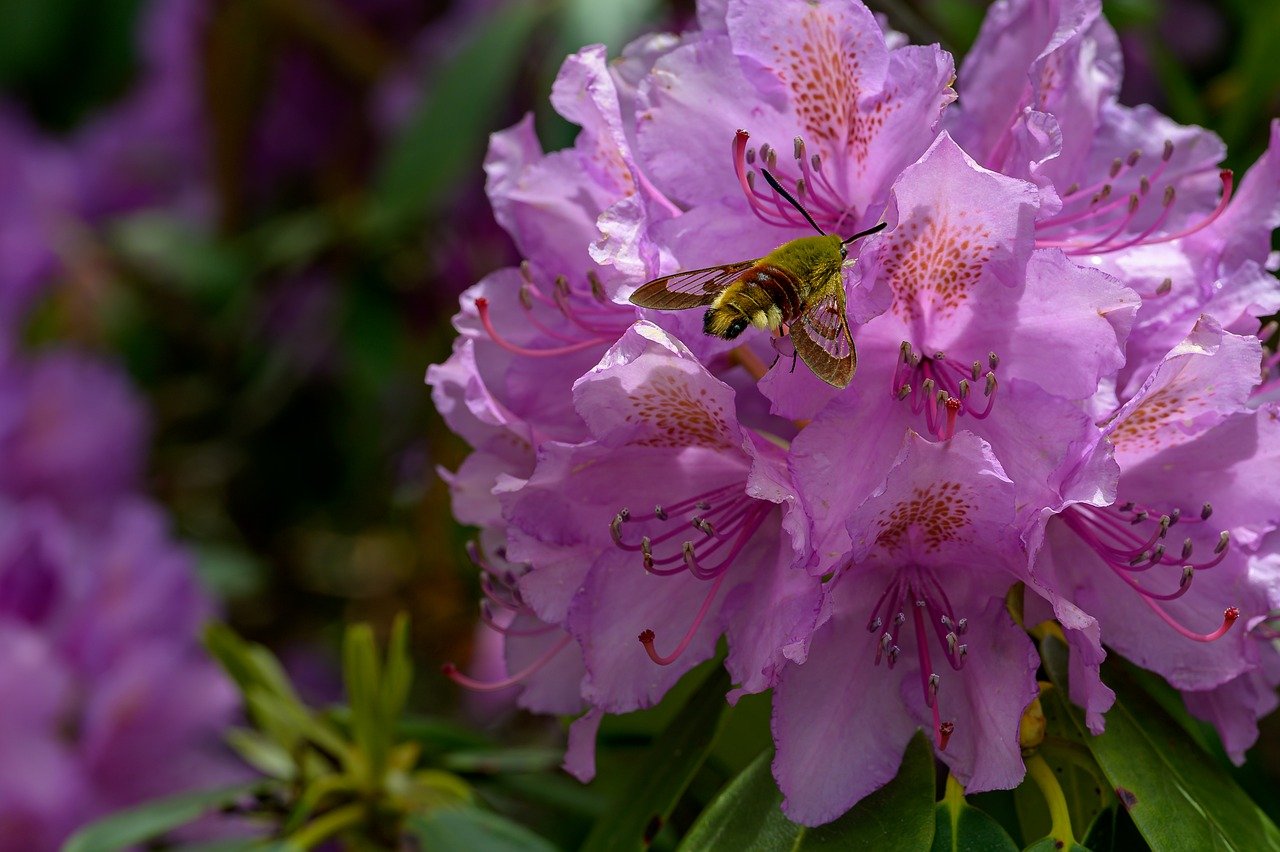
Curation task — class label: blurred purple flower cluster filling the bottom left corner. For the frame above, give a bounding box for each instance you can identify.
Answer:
[0,499,238,849]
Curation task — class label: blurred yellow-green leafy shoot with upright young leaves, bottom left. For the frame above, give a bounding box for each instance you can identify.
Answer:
[72,615,568,852]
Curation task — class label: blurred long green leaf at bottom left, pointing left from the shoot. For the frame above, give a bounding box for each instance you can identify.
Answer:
[63,782,270,852]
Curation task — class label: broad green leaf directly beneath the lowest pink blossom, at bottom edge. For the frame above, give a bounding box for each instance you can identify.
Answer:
[680,733,936,852]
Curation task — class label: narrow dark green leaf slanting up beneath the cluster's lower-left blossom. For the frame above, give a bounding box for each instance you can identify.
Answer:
[582,667,730,852]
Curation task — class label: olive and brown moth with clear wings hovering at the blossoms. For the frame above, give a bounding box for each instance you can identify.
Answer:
[631,169,886,388]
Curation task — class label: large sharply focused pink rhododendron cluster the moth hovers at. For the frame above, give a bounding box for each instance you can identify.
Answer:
[428,0,1280,824]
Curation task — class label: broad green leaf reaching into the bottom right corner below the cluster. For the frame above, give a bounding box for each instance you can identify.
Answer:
[1041,637,1280,852]
